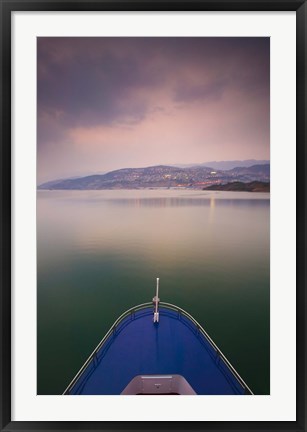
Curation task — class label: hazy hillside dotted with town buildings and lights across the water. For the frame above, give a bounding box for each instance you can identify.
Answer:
[38,165,270,190]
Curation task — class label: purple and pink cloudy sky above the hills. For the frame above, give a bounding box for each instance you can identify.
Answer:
[37,37,270,183]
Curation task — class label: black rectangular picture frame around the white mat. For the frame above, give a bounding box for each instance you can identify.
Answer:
[0,0,307,431]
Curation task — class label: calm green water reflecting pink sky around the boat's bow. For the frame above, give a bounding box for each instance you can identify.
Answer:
[37,190,270,394]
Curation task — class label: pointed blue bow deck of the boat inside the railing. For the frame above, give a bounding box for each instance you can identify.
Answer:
[65,305,251,395]
